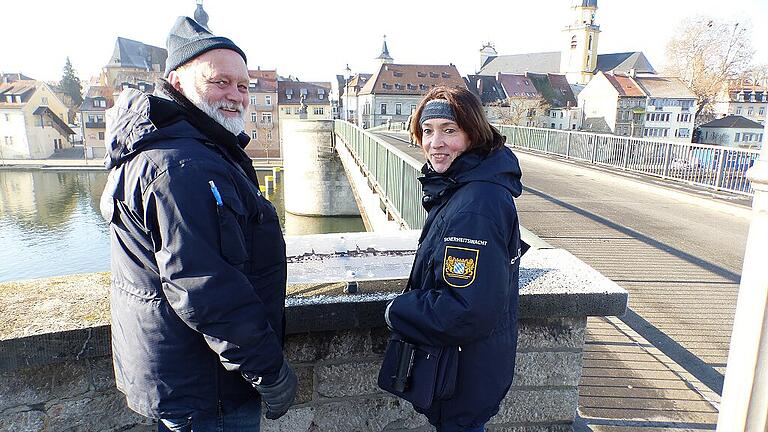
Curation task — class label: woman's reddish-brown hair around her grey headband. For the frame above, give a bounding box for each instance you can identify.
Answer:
[410,86,506,154]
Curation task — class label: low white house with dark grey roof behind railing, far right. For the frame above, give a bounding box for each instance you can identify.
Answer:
[698,115,765,149]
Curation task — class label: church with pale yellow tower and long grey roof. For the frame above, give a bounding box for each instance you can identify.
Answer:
[478,0,656,84]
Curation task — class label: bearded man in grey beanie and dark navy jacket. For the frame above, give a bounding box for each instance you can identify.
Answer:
[101,17,297,432]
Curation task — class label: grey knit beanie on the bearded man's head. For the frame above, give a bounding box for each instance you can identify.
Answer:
[163,17,248,78]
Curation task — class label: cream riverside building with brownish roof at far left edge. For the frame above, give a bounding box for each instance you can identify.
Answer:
[0,74,74,159]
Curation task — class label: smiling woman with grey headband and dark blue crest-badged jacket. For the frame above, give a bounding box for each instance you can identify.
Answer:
[386,87,522,432]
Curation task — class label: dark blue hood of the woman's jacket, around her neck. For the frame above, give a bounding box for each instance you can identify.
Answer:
[419,146,523,204]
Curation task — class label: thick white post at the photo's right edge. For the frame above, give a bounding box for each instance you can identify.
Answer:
[717,120,768,432]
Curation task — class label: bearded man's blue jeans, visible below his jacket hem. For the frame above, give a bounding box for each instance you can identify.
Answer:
[157,398,261,432]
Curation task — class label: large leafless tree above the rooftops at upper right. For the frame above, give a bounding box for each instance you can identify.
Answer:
[665,16,754,124]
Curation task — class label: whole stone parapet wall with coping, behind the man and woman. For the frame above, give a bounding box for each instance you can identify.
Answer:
[0,232,627,432]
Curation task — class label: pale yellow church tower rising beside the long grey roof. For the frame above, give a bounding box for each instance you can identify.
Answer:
[560,0,600,84]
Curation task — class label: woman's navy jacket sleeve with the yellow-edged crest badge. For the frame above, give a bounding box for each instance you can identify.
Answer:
[387,207,518,346]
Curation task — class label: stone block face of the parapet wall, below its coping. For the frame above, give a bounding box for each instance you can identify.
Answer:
[0,317,586,432]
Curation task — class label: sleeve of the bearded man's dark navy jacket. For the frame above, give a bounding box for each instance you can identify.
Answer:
[143,162,285,382]
